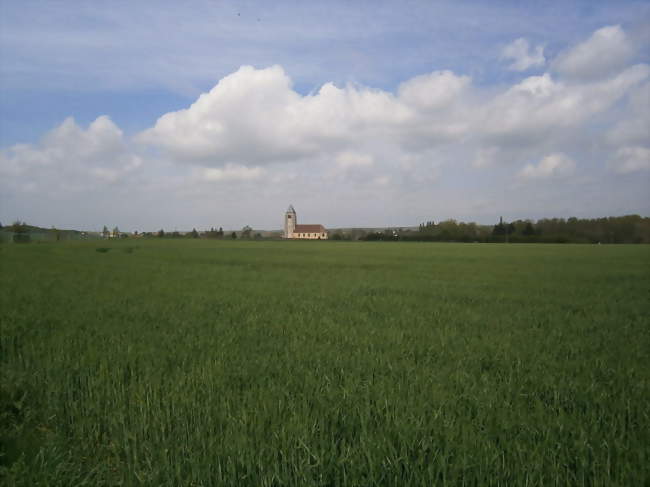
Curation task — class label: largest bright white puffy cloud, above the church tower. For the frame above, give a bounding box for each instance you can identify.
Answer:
[138,66,409,166]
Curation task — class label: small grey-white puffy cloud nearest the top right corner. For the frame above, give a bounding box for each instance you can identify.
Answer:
[553,25,634,81]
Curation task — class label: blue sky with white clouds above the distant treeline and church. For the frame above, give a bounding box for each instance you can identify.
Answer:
[0,0,650,231]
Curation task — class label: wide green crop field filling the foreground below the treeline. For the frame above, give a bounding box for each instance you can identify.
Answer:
[0,240,650,486]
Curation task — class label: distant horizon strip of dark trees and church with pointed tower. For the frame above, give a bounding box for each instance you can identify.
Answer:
[0,212,650,244]
